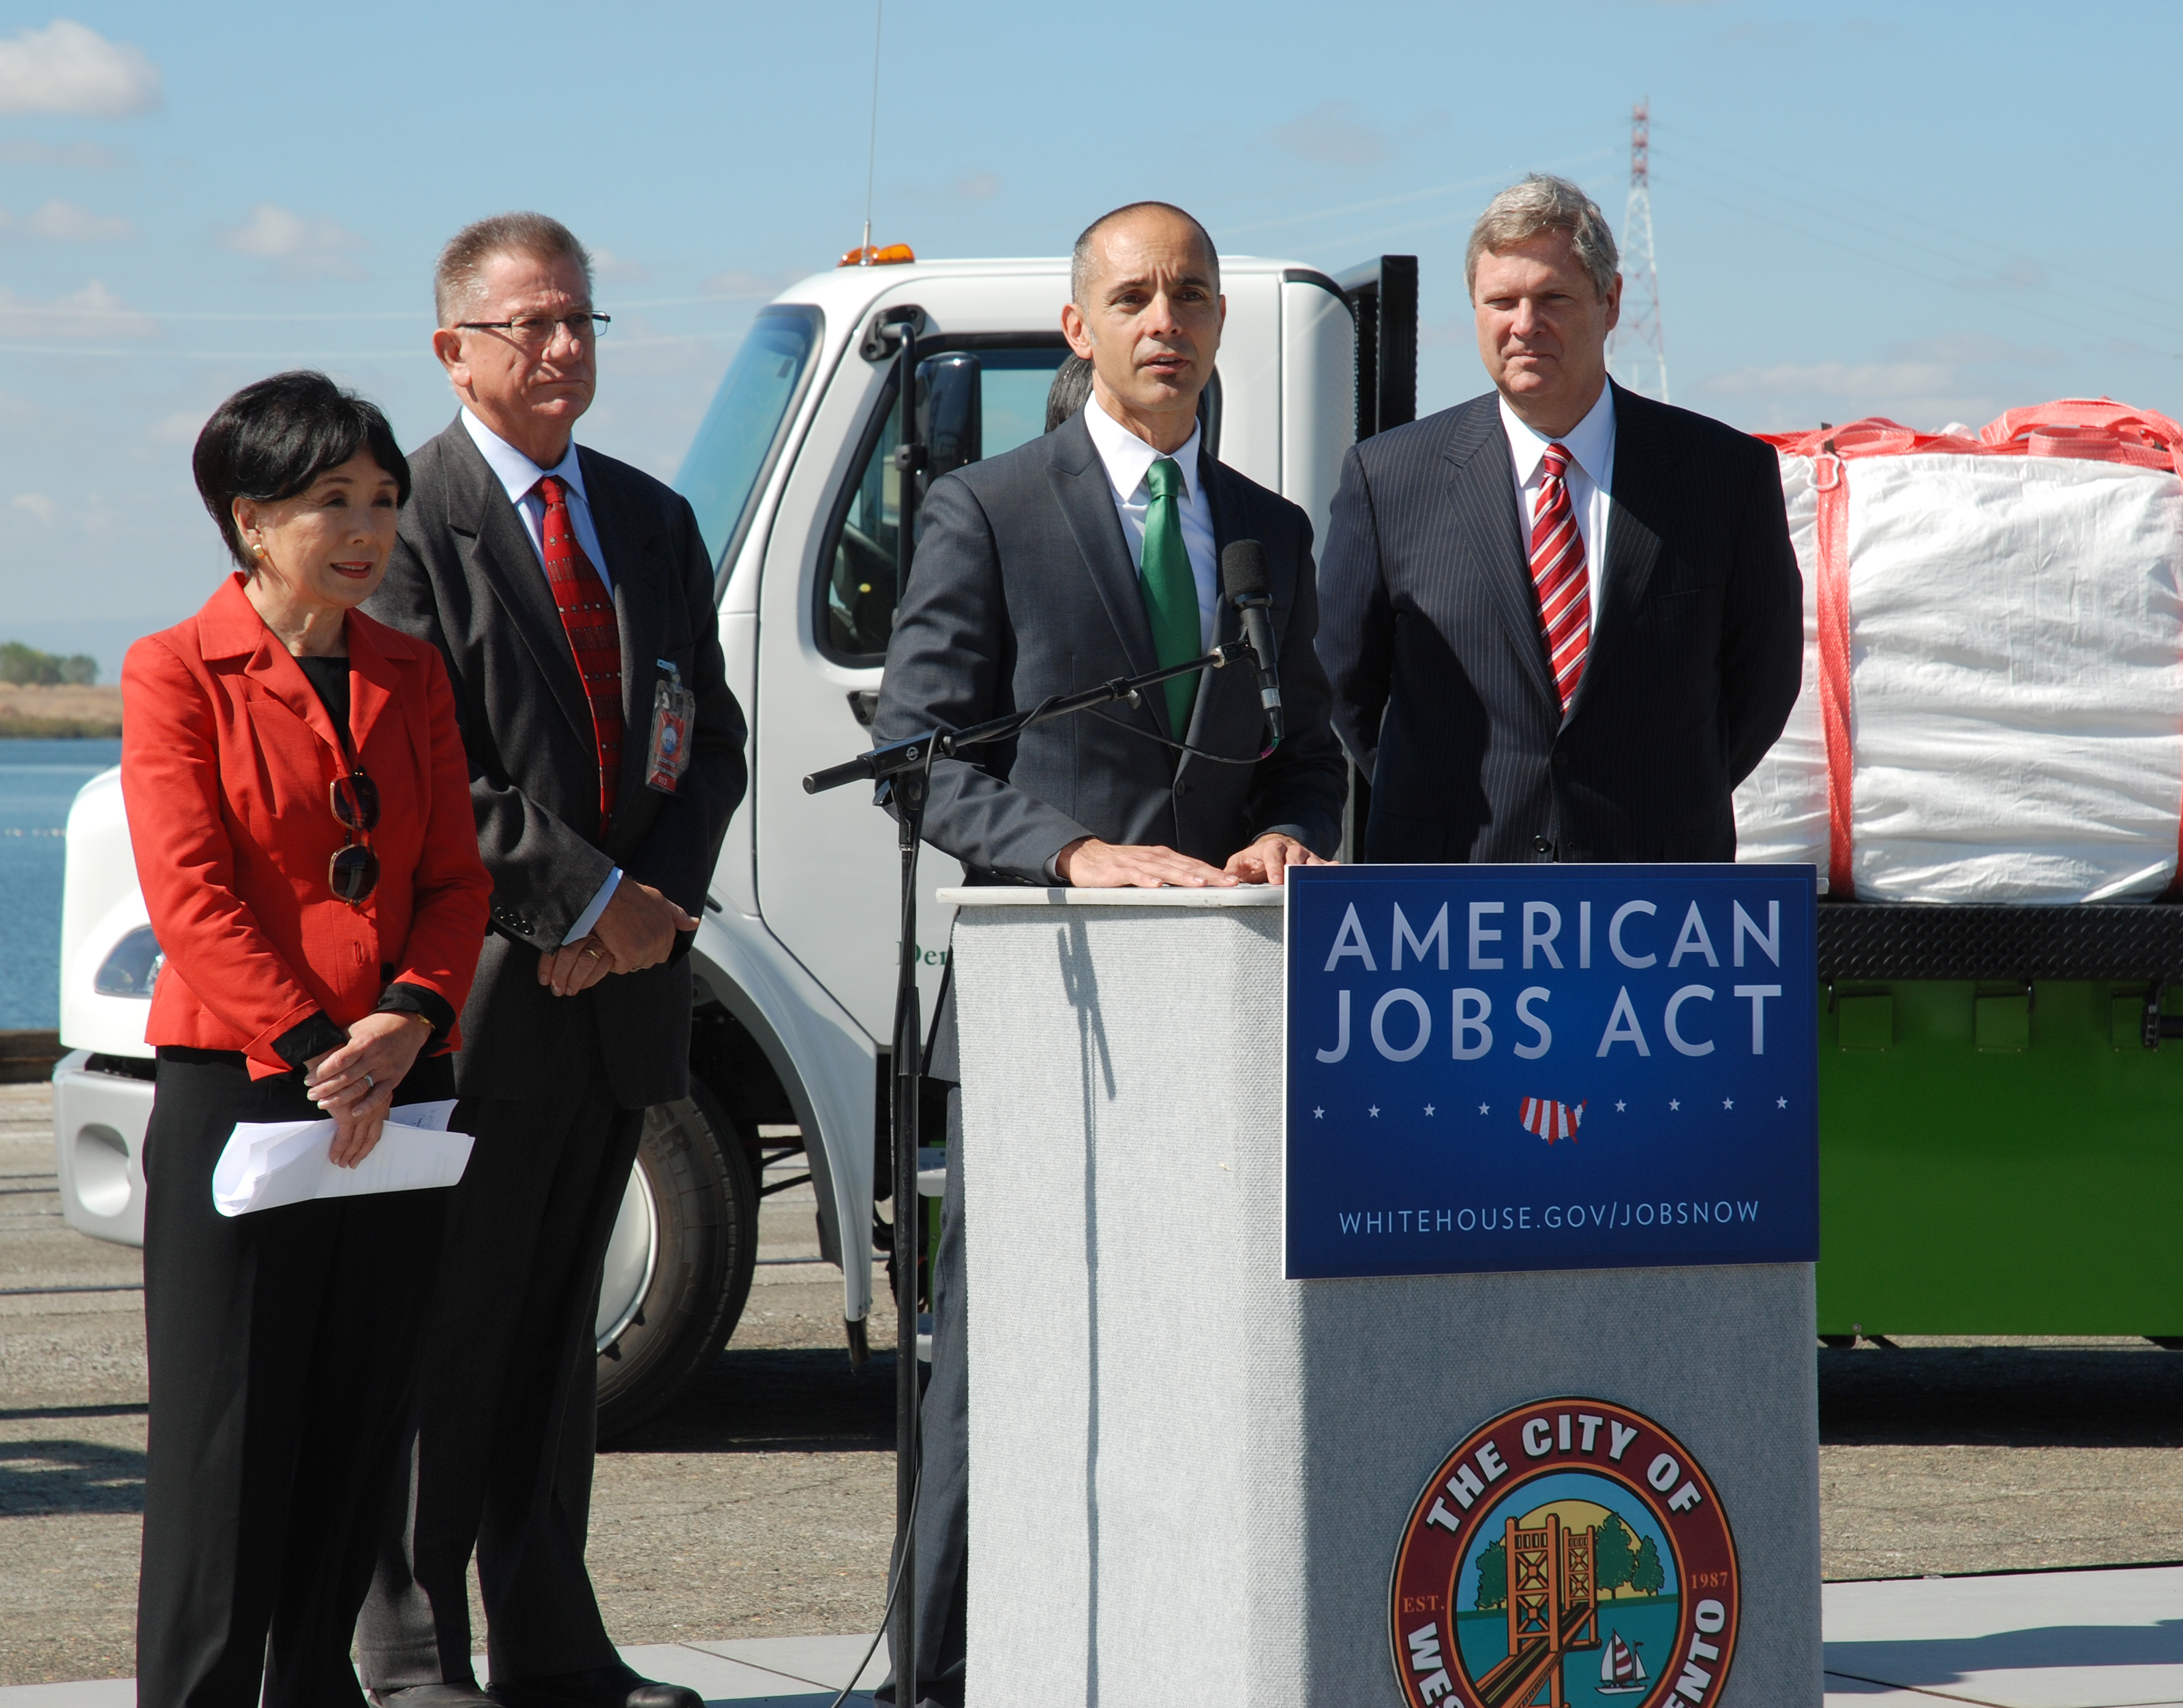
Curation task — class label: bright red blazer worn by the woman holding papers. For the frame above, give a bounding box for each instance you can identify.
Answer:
[122,577,491,1079]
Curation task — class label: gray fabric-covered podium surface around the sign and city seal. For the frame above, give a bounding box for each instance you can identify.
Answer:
[941,889,1820,1708]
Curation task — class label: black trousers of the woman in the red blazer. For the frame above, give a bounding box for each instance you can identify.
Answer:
[138,1049,454,1708]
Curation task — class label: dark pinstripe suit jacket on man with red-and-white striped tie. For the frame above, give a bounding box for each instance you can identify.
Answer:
[1319,387,1803,863]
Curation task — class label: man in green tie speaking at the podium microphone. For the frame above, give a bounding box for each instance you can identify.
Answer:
[873,201,1344,1708]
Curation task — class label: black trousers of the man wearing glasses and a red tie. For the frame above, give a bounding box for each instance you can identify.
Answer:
[356,1046,644,1690]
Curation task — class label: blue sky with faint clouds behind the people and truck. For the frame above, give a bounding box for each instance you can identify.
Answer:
[0,0,2183,668]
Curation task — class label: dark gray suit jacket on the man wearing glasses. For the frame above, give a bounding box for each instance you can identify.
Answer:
[365,419,744,1109]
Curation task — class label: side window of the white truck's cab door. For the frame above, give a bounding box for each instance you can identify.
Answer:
[817,334,1068,668]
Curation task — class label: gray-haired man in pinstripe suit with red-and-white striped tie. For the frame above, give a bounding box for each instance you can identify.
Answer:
[1319,175,1803,860]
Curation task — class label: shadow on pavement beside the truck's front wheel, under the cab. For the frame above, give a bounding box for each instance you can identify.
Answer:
[601,1347,895,1452]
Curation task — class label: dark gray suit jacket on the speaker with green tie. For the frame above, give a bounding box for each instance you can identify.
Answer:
[873,415,1344,884]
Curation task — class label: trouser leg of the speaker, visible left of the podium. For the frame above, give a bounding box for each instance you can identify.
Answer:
[895,1085,969,1708]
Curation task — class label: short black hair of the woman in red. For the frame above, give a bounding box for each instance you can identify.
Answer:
[190,369,408,570]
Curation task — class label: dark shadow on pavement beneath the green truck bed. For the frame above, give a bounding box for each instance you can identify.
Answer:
[1818,1345,2183,1448]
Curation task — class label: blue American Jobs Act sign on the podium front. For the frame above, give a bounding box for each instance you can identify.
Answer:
[1286,865,1818,1278]
